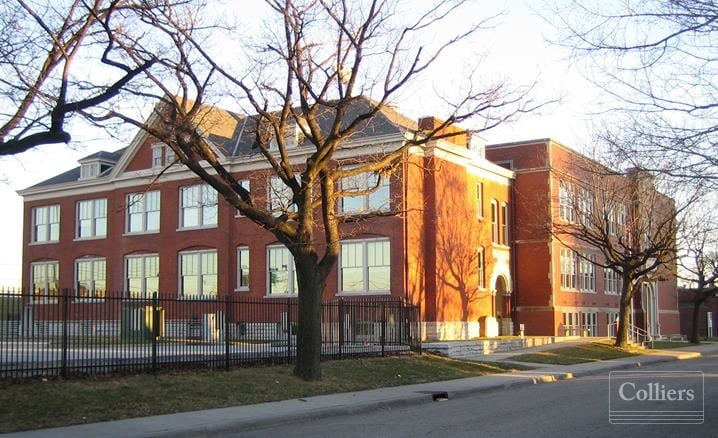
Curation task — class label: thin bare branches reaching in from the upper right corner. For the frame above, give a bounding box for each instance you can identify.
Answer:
[550,0,718,187]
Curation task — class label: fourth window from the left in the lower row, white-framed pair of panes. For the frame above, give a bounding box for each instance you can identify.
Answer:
[180,250,217,299]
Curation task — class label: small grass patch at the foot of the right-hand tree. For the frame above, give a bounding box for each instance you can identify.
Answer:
[509,342,641,365]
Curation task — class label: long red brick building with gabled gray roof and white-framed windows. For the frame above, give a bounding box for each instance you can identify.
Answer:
[20,104,678,339]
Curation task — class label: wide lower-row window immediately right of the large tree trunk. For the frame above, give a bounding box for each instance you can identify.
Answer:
[340,239,391,293]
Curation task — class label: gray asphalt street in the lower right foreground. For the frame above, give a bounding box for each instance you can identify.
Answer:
[223,353,718,438]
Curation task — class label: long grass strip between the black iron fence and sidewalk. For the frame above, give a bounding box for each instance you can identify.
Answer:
[0,354,521,433]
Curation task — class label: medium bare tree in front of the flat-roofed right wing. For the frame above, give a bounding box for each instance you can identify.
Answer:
[550,160,683,348]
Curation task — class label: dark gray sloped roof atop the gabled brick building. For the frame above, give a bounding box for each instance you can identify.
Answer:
[23,96,418,189]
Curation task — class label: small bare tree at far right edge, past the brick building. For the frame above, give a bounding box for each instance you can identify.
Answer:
[678,207,718,343]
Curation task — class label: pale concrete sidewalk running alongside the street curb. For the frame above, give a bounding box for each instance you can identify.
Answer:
[6,343,718,438]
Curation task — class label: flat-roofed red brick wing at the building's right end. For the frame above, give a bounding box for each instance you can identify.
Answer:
[486,139,679,336]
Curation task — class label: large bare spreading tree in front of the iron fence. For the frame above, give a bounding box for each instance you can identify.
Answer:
[81,0,544,380]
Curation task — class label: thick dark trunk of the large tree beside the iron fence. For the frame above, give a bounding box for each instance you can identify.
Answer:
[294,256,326,381]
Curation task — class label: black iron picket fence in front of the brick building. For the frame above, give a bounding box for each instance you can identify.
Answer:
[0,290,420,378]
